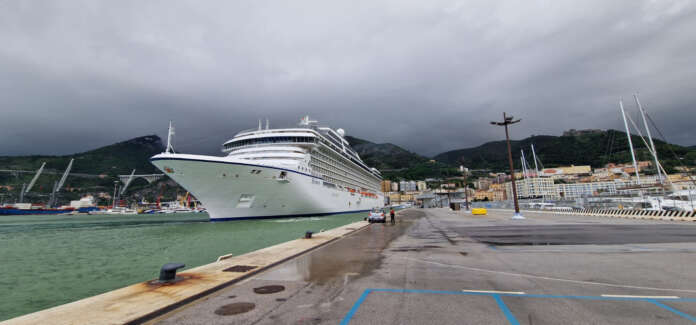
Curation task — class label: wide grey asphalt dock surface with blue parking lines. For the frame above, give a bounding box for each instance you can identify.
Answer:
[152,209,696,324]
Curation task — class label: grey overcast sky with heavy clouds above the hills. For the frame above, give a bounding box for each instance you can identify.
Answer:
[0,0,696,155]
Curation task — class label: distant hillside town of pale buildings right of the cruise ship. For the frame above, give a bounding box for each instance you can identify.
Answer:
[381,161,694,205]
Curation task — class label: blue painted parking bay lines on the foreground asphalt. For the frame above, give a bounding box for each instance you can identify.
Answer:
[341,288,696,325]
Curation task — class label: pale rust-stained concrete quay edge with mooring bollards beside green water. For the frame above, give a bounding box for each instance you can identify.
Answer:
[0,221,368,324]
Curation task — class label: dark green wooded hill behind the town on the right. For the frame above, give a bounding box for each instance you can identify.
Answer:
[434,130,696,171]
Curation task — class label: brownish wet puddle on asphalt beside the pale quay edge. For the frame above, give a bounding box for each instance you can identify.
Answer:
[257,210,424,284]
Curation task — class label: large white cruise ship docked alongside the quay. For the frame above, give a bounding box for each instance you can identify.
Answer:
[150,116,384,221]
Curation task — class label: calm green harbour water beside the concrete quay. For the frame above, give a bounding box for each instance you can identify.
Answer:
[0,213,365,320]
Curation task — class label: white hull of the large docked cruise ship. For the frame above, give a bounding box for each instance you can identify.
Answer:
[151,153,384,221]
